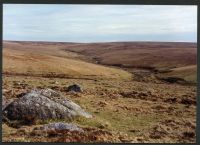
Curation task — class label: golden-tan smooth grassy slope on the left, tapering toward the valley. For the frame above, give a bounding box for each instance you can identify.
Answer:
[3,41,131,79]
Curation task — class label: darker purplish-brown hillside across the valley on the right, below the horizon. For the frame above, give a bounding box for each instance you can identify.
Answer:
[60,42,197,82]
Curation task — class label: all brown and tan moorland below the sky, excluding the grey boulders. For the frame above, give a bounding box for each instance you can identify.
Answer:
[2,41,197,143]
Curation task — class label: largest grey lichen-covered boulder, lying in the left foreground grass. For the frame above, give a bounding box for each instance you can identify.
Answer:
[3,89,92,120]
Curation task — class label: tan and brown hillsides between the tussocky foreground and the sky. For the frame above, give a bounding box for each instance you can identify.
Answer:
[3,41,197,83]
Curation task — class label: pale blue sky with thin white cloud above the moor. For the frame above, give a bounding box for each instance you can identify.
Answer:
[3,4,197,42]
